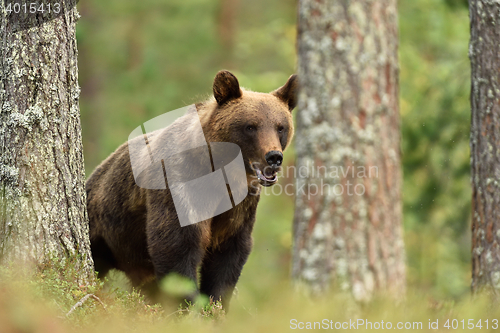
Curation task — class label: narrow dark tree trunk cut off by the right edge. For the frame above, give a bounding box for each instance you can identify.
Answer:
[469,0,500,295]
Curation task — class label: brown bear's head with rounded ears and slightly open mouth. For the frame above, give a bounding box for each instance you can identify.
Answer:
[205,71,298,186]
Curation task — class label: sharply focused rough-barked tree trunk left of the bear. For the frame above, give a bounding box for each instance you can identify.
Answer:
[0,1,94,282]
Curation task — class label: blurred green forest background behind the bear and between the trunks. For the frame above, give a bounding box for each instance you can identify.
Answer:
[77,0,471,313]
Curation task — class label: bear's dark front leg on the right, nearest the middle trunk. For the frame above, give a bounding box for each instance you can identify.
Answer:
[200,223,253,311]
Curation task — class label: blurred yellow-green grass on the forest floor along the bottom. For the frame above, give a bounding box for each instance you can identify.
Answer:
[0,264,500,333]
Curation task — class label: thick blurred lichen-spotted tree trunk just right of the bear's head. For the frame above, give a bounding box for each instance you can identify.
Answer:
[292,0,405,301]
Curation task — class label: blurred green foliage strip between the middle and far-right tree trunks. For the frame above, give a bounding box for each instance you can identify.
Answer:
[399,0,471,297]
